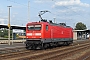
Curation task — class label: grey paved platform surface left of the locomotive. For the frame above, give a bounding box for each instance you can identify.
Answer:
[0,43,25,49]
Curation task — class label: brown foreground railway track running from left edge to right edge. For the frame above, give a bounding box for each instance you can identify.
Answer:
[0,40,90,60]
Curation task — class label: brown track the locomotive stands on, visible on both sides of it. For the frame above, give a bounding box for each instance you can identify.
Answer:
[0,40,89,55]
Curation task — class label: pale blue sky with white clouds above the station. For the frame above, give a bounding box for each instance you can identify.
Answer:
[0,0,90,29]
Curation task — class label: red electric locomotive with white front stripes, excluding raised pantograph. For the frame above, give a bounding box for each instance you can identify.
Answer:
[26,10,73,49]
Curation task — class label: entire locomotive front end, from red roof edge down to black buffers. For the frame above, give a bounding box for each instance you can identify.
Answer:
[26,23,42,49]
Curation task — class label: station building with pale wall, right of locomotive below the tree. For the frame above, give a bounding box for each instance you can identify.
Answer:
[73,30,90,40]
